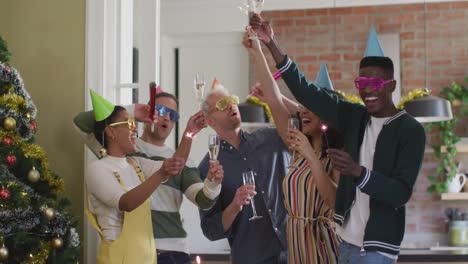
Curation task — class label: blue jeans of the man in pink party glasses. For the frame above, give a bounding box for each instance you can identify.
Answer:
[338,241,396,264]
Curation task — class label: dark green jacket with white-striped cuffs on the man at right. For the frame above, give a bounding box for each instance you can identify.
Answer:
[277,56,426,255]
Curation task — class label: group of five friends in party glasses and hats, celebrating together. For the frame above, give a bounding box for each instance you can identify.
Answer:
[77,15,425,264]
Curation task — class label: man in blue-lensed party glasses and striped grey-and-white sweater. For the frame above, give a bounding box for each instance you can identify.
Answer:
[137,90,223,264]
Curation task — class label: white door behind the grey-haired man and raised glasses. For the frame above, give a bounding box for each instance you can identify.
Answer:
[161,32,249,253]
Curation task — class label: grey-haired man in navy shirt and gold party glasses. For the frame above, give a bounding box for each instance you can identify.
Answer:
[199,81,289,264]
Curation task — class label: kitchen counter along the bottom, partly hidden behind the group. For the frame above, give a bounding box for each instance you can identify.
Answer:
[192,249,468,264]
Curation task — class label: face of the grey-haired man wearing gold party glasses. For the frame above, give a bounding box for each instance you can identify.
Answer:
[206,92,241,131]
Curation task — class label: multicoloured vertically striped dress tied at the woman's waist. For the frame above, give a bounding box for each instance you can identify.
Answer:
[283,156,340,264]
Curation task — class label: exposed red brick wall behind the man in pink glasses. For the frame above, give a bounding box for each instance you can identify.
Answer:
[251,1,468,249]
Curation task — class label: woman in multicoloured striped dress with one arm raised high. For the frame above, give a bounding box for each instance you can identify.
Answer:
[243,29,339,264]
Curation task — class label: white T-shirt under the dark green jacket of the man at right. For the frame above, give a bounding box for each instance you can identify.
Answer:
[337,116,395,258]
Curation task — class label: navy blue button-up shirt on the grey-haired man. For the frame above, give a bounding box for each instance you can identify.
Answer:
[199,128,289,264]
